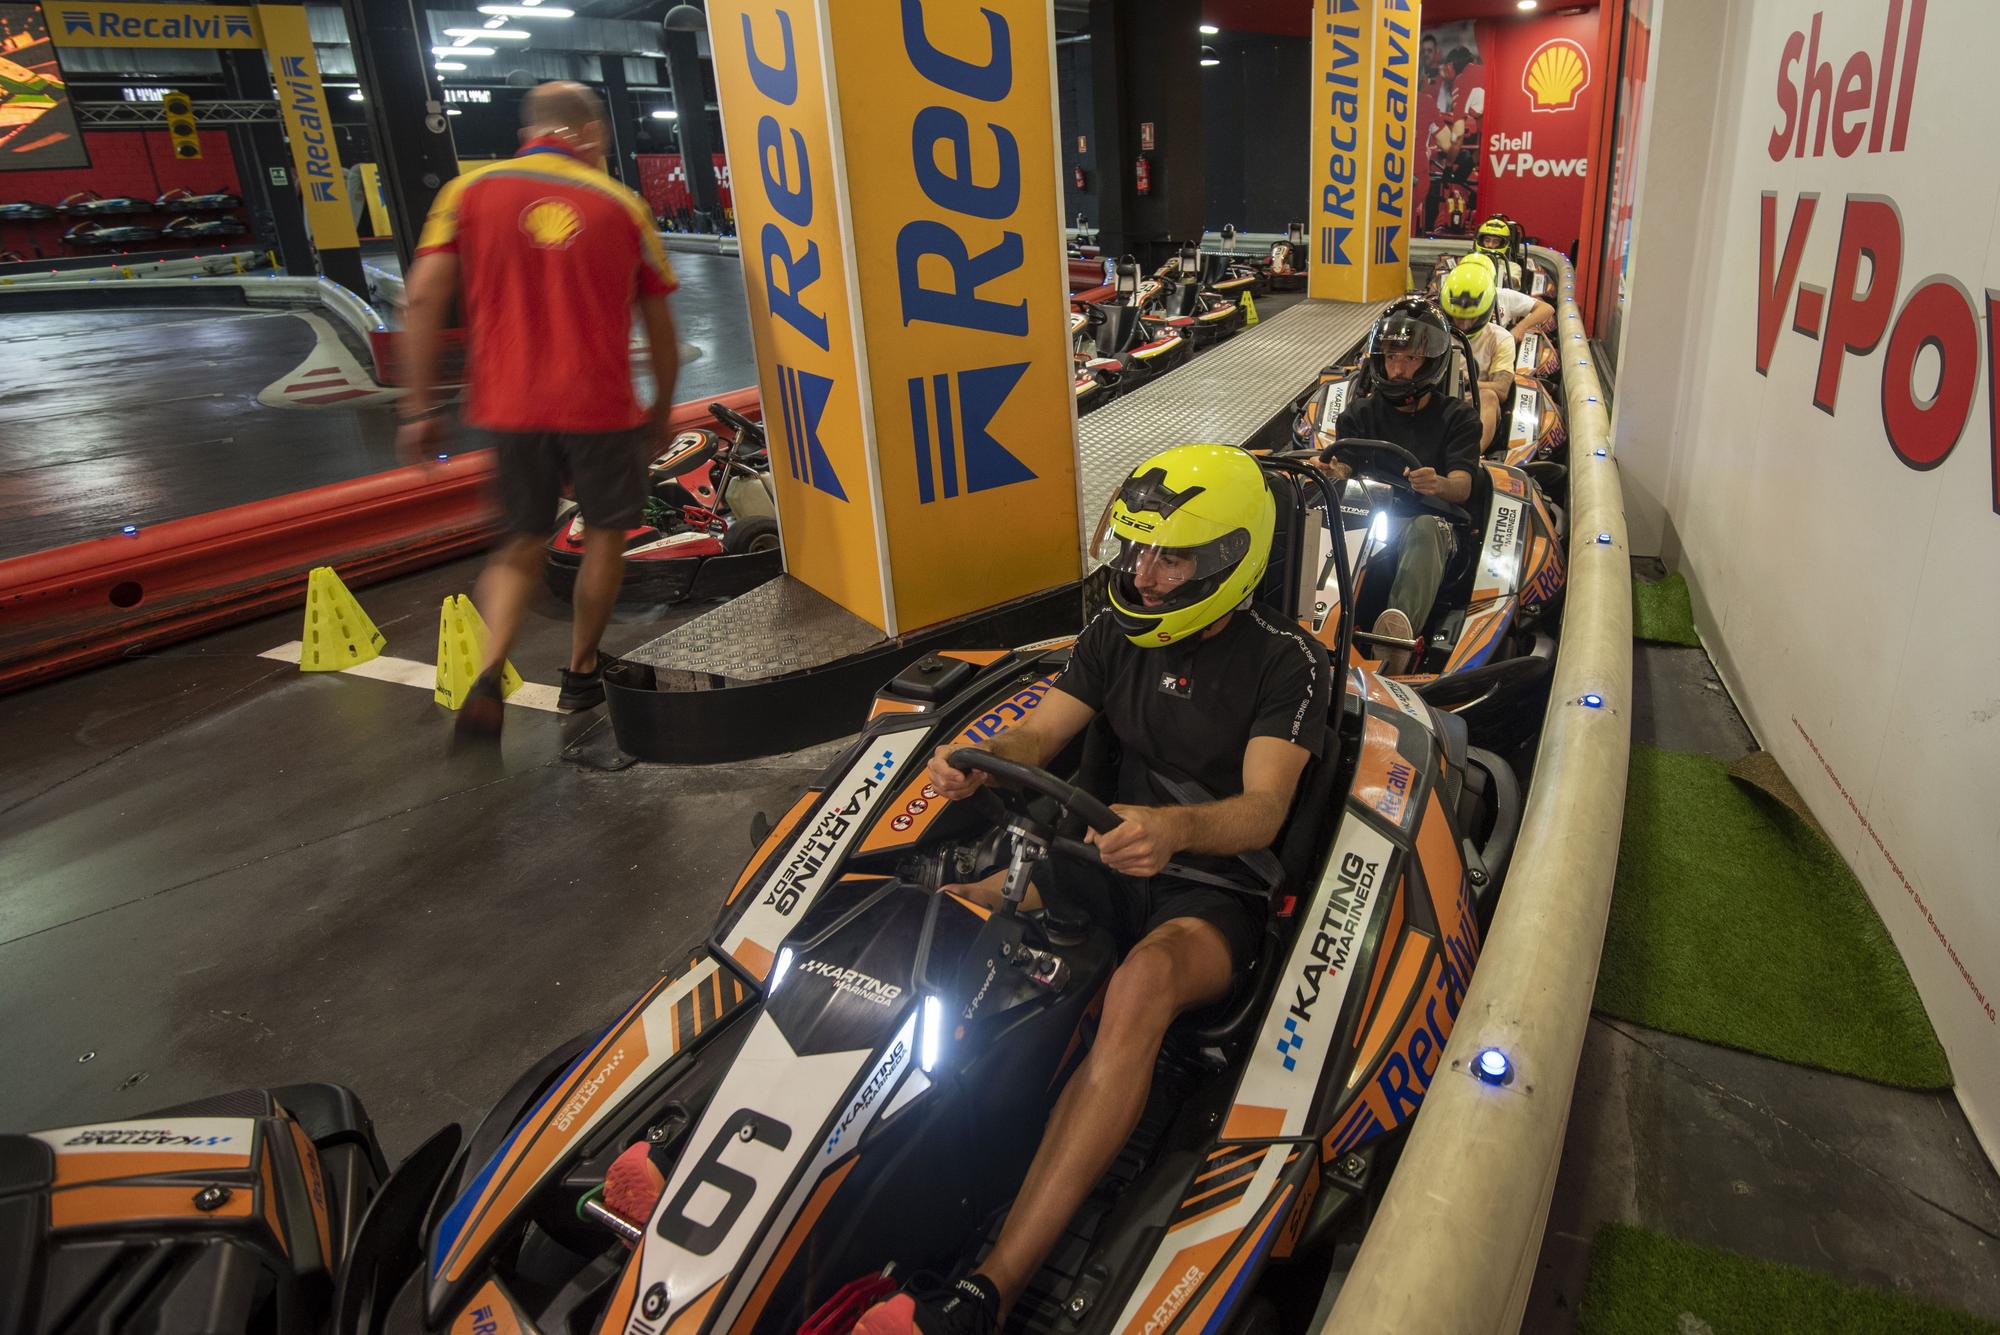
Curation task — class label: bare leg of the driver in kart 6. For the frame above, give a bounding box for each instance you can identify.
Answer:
[980,917,1230,1321]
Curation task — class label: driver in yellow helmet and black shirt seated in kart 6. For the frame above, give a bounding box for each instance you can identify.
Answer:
[854,446,1334,1335]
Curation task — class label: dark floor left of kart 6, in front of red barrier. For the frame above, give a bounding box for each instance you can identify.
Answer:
[0,562,822,1161]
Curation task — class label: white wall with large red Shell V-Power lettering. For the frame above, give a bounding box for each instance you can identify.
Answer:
[1616,0,2000,1157]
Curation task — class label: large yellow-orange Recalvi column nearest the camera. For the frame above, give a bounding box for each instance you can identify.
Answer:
[708,0,1080,634]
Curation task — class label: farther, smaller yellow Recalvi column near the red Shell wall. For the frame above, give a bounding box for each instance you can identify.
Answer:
[1306,0,1422,302]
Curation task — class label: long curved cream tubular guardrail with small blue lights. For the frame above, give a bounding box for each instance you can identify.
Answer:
[1322,246,1632,1335]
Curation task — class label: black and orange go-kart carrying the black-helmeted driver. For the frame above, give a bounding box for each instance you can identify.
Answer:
[1292,334,1568,749]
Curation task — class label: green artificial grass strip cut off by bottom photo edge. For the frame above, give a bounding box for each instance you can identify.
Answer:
[1576,1223,2000,1335]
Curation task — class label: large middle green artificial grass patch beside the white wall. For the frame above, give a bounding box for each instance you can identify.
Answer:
[1596,745,1952,1089]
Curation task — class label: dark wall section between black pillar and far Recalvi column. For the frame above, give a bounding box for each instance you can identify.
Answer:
[1202,32,1312,232]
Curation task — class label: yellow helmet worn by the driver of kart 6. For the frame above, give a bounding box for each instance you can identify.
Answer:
[1092,446,1278,650]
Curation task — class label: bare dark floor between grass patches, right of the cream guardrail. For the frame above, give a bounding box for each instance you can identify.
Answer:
[1522,595,2000,1335]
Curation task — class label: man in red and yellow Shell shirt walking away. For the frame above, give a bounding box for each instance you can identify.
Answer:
[398,82,680,737]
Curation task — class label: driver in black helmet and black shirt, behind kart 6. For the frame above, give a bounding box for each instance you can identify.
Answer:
[1330,296,1480,673]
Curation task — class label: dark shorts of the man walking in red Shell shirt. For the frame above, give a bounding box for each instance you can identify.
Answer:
[480,426,652,536]
